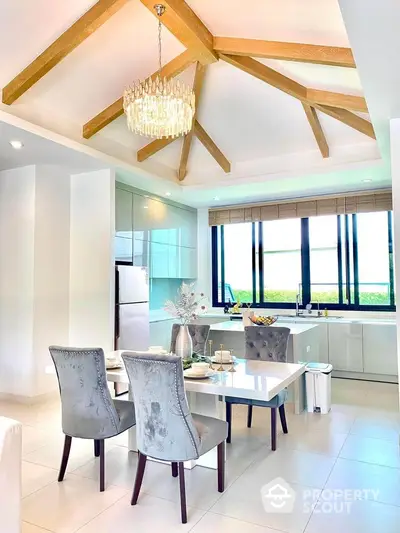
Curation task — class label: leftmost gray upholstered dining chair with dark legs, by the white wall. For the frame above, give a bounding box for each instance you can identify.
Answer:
[49,346,135,492]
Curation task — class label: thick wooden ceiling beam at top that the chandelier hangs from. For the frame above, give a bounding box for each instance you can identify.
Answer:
[141,0,218,65]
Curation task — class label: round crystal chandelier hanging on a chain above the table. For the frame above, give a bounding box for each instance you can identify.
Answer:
[124,4,195,139]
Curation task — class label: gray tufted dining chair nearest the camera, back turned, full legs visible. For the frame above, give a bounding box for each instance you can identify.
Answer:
[122,352,228,524]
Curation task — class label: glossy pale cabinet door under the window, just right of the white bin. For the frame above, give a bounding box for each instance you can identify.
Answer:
[328,323,364,372]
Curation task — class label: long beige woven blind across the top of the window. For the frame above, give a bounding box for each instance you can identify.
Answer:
[209,190,392,226]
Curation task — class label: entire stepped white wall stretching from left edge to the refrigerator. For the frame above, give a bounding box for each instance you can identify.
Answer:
[0,166,115,399]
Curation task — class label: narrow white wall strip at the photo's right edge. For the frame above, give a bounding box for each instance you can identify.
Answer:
[390,118,400,400]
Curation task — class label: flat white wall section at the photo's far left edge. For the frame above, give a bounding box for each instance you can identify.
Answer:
[0,166,35,395]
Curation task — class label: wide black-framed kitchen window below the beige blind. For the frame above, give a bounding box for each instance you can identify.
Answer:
[212,211,395,310]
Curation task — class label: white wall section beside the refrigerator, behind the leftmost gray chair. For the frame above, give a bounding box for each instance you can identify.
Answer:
[69,169,115,351]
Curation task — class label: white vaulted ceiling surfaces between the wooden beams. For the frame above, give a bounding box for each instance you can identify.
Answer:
[0,0,390,205]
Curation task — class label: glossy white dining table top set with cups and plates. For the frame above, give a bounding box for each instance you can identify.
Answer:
[106,350,305,401]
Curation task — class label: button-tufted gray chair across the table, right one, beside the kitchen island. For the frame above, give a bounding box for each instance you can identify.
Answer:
[225,326,290,451]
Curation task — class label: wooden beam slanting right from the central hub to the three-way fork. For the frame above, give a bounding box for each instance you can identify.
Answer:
[220,54,307,100]
